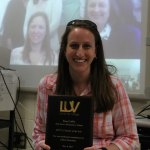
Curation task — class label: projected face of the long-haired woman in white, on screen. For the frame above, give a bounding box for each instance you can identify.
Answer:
[28,16,46,44]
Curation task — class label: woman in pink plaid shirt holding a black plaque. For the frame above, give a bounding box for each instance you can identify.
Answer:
[32,20,139,150]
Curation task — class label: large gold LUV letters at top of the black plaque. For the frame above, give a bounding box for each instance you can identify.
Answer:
[60,101,80,113]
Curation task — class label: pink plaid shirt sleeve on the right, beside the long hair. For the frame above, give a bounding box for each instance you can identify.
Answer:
[112,79,139,150]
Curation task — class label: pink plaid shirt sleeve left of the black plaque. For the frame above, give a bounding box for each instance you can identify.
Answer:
[32,79,46,150]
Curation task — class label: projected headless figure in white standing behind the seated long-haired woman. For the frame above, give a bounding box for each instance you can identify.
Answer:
[23,0,62,52]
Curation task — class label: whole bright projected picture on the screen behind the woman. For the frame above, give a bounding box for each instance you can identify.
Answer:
[0,0,142,91]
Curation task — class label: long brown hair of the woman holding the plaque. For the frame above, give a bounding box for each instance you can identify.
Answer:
[56,22,118,113]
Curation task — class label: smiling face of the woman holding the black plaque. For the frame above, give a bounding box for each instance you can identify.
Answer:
[65,28,96,75]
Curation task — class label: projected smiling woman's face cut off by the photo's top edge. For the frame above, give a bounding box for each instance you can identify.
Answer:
[87,0,110,28]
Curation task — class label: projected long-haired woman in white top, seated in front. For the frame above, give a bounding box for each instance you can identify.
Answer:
[10,12,58,65]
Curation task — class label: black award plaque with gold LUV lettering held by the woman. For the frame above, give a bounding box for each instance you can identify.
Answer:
[45,95,94,150]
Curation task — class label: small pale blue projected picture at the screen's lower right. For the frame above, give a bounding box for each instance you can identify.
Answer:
[106,59,140,92]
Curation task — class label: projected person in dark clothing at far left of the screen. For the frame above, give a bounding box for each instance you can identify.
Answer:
[0,0,28,50]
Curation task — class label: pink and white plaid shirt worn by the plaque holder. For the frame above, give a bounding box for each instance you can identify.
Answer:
[32,74,139,150]
